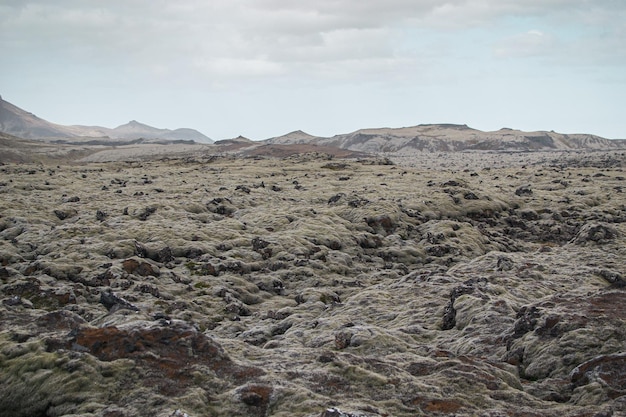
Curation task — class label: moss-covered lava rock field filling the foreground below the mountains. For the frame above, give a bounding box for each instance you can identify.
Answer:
[0,141,626,417]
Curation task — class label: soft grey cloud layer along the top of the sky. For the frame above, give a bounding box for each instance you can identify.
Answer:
[0,0,626,82]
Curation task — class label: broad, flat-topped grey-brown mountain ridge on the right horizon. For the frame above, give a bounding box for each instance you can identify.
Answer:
[266,124,626,154]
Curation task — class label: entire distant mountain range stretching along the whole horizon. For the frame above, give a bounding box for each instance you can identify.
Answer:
[0,97,626,155]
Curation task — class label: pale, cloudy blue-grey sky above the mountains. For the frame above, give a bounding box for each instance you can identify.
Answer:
[0,0,626,140]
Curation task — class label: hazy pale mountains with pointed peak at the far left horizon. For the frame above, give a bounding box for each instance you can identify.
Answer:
[0,97,213,143]
